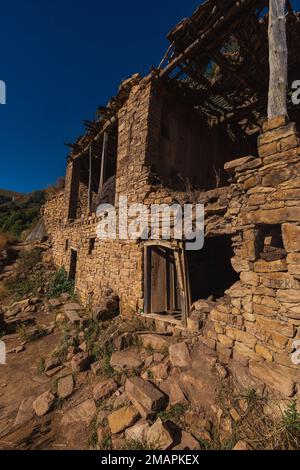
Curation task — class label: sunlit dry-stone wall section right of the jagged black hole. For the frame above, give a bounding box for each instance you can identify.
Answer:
[199,119,300,397]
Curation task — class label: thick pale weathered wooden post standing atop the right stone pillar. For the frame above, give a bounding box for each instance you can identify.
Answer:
[268,0,288,119]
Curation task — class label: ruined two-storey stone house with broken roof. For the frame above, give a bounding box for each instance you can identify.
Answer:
[43,0,300,397]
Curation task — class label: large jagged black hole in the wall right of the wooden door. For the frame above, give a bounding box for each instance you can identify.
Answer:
[186,235,239,303]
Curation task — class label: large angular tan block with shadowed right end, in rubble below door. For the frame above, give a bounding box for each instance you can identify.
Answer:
[125,377,168,418]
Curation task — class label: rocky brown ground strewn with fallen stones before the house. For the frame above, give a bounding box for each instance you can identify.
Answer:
[0,245,299,450]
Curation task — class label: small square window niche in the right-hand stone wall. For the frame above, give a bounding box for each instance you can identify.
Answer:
[256,224,287,261]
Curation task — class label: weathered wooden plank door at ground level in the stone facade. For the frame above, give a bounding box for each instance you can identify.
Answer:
[145,246,181,320]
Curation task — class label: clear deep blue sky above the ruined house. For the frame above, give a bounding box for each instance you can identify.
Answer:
[0,0,300,192]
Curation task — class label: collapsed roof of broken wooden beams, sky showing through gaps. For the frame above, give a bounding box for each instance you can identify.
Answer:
[157,0,300,132]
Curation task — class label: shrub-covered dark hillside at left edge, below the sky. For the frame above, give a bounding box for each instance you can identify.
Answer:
[0,189,46,239]
